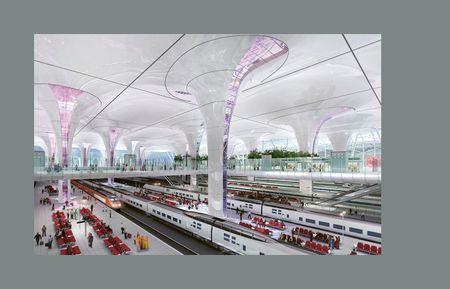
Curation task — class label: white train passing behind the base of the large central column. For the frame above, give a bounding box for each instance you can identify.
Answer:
[137,184,382,243]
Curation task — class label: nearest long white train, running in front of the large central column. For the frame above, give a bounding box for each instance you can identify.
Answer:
[74,181,310,255]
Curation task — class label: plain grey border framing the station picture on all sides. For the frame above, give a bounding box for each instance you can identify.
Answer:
[0,0,450,289]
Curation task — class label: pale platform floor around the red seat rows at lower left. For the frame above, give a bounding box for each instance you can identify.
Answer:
[30,183,181,255]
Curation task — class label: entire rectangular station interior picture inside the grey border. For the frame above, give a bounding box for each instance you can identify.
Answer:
[30,34,382,254]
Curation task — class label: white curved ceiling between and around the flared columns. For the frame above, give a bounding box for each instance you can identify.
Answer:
[34,34,381,150]
